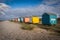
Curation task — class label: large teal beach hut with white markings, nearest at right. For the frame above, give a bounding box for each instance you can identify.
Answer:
[42,13,57,25]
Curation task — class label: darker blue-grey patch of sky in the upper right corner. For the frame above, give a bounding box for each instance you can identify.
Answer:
[43,0,60,11]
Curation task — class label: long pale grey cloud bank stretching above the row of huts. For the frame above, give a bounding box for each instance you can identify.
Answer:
[10,4,59,16]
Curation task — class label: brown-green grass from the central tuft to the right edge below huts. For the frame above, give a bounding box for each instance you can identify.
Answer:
[22,23,60,36]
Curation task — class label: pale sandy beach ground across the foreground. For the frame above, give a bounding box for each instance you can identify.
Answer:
[0,21,60,40]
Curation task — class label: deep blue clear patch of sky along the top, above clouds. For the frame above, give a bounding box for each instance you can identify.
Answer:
[1,0,43,8]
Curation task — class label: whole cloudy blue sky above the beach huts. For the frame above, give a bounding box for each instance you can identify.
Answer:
[0,0,60,20]
